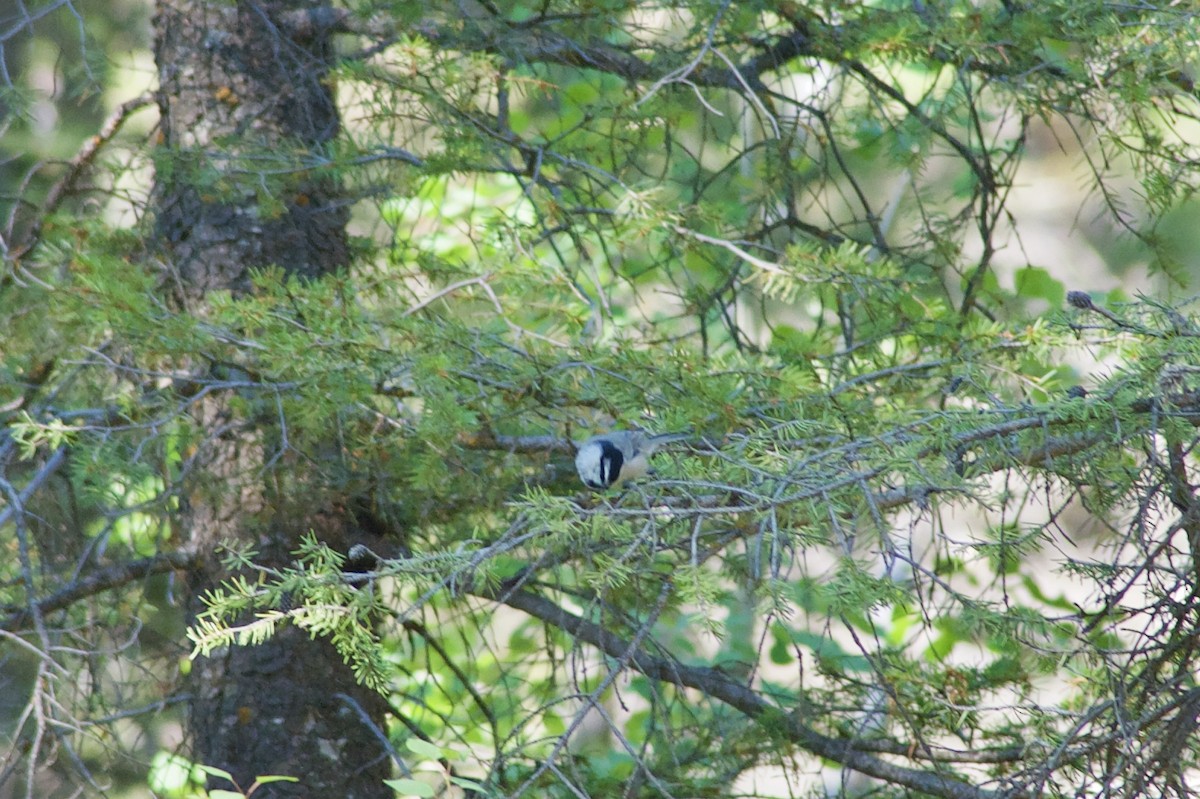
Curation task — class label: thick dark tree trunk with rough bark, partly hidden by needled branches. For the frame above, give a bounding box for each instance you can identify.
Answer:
[155,0,391,797]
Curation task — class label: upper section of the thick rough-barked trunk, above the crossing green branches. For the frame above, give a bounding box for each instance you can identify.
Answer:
[155,0,348,299]
